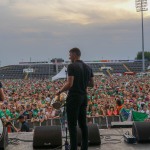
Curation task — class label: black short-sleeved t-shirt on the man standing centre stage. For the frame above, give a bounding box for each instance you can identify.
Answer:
[67,60,93,94]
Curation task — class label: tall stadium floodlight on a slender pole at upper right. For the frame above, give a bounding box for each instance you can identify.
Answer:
[135,0,148,72]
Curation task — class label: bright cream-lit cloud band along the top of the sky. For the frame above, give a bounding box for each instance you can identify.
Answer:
[1,0,149,25]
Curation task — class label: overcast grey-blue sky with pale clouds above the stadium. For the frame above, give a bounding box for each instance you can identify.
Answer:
[0,0,150,66]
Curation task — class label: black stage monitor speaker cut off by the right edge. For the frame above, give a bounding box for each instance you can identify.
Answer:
[132,122,150,143]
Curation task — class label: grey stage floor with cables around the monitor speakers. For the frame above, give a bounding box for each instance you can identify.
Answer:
[6,128,150,150]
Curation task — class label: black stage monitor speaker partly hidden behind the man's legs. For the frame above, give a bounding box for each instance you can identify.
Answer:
[77,124,101,146]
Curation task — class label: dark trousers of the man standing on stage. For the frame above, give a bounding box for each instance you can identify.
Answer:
[66,94,88,150]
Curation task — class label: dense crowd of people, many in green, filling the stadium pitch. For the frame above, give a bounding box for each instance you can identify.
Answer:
[0,75,150,129]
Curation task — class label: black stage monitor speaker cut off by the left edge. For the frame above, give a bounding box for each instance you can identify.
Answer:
[0,119,8,150]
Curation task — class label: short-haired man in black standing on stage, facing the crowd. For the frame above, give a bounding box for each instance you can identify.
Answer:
[56,48,94,150]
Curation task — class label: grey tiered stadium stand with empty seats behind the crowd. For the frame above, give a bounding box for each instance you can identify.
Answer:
[0,61,150,79]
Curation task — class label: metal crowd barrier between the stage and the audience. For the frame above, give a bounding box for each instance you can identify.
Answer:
[10,115,121,129]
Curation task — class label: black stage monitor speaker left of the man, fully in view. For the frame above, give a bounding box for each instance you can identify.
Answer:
[33,126,62,149]
